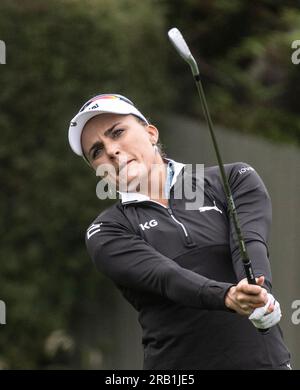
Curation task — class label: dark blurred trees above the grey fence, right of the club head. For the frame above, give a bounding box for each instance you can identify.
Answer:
[165,0,300,145]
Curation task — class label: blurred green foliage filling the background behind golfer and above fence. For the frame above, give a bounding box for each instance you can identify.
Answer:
[0,0,300,369]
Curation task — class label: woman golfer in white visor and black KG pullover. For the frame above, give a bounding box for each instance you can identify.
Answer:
[69,95,290,369]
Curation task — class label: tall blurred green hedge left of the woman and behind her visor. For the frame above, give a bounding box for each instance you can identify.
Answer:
[0,0,170,368]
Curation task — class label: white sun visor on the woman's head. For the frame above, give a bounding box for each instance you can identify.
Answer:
[69,94,149,156]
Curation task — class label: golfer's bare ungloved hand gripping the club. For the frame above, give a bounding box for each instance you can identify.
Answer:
[225,276,274,317]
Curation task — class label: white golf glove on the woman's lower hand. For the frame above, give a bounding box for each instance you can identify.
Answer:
[248,294,282,329]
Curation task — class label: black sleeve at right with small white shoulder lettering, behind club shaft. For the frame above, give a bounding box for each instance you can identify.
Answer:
[228,163,272,291]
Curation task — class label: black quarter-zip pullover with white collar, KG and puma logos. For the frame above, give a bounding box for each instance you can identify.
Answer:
[86,160,289,369]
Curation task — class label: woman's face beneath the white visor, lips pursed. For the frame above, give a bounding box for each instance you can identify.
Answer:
[81,114,162,190]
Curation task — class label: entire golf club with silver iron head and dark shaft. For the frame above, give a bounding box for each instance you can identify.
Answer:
[168,28,256,284]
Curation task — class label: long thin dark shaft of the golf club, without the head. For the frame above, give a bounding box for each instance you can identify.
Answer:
[194,74,256,284]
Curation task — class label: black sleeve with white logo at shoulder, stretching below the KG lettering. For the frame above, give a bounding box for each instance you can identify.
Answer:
[86,218,232,310]
